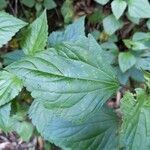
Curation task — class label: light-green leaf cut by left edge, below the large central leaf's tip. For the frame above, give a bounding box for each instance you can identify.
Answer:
[0,71,23,106]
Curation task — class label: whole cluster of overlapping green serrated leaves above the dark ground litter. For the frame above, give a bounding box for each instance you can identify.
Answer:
[0,0,150,150]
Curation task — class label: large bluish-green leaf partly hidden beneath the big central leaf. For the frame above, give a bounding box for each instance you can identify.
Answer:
[29,101,119,150]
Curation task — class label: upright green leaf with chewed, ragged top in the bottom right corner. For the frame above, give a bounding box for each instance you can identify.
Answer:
[120,89,150,150]
